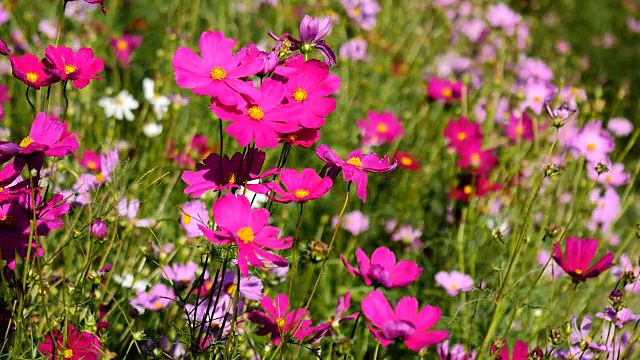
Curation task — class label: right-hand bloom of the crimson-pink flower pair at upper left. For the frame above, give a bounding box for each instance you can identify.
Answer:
[43,46,104,89]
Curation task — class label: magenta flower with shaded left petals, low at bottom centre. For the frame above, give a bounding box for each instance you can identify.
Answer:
[249,294,313,345]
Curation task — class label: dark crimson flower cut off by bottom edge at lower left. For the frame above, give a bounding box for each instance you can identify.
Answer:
[38,324,103,360]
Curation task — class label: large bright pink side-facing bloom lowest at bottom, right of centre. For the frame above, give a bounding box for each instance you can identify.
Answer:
[362,290,449,351]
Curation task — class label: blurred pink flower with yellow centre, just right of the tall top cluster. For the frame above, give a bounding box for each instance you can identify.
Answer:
[358,111,404,145]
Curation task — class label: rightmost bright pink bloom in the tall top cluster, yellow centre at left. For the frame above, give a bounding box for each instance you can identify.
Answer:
[286,55,340,129]
